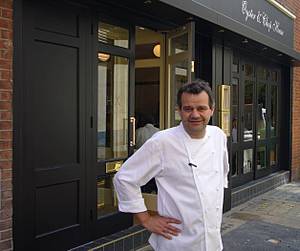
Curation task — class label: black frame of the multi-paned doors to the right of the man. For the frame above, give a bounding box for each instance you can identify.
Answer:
[230,51,282,188]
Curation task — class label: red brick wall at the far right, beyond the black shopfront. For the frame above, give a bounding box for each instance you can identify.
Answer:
[278,0,300,180]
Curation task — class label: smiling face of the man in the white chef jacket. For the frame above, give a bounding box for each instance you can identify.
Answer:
[179,91,214,138]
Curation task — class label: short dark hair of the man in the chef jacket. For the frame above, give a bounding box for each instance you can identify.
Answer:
[177,79,215,109]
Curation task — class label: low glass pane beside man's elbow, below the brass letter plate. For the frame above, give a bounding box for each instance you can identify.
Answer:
[97,176,118,219]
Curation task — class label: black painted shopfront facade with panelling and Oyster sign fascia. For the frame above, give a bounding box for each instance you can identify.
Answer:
[13,0,300,250]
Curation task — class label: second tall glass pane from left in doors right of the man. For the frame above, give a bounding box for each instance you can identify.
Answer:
[244,80,253,141]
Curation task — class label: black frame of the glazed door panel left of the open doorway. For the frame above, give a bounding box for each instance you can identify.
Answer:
[87,14,135,239]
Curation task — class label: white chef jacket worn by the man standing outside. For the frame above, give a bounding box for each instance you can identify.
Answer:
[114,124,229,251]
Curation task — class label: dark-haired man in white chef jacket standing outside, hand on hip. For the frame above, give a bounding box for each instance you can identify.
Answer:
[114,81,229,251]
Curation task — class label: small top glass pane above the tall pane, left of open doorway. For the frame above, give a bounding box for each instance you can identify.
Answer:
[98,22,129,48]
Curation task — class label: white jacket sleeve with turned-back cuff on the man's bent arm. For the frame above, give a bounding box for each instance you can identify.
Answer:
[114,138,163,213]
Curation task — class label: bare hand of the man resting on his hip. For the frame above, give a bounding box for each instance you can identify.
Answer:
[136,212,181,240]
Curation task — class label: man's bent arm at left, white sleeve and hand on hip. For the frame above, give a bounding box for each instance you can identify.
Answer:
[114,139,180,239]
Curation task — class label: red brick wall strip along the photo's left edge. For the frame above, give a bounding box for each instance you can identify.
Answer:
[0,0,13,251]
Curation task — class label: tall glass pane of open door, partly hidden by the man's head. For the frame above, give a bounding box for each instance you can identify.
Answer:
[170,60,188,125]
